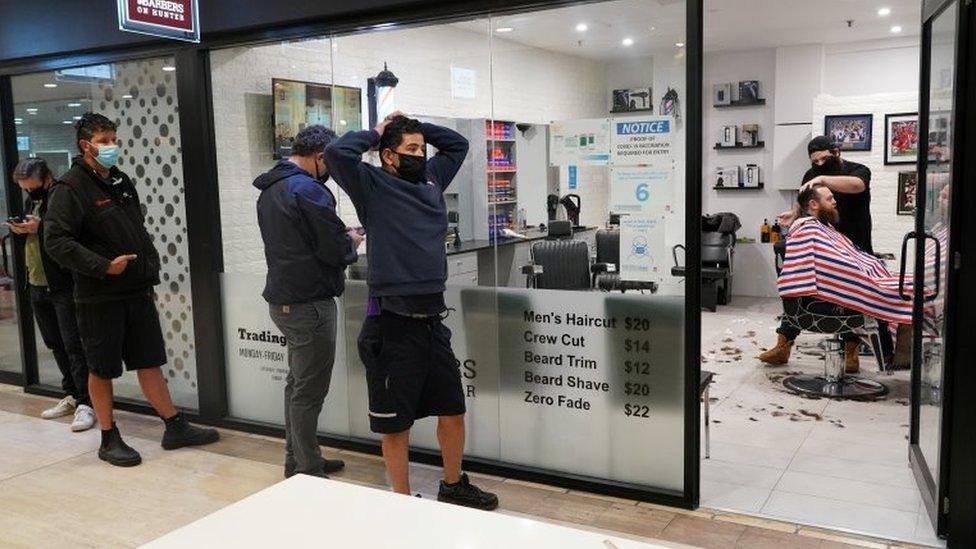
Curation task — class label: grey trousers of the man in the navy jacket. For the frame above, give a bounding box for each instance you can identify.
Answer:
[270,299,337,475]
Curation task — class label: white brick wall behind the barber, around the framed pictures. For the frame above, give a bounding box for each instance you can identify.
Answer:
[813,92,918,264]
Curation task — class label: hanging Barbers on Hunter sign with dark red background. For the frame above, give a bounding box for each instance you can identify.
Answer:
[118,0,200,42]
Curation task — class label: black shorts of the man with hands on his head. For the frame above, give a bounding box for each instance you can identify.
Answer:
[359,312,465,433]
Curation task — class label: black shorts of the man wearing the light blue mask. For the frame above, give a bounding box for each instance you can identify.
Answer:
[76,292,166,379]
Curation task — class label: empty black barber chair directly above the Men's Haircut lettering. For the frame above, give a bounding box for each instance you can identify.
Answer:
[522,220,593,291]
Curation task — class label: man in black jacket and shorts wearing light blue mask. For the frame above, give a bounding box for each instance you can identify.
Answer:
[44,113,219,467]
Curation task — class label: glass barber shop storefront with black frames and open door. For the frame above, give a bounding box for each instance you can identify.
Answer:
[0,0,976,546]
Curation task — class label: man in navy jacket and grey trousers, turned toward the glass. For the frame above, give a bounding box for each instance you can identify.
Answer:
[254,125,363,477]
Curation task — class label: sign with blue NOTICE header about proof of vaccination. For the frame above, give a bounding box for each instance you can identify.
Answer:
[610,116,674,166]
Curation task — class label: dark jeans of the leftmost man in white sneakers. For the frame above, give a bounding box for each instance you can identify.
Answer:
[30,286,91,406]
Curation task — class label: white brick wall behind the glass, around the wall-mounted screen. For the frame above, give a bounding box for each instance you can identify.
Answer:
[211,25,608,274]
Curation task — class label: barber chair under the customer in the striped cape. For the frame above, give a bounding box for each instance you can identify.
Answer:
[783,298,891,399]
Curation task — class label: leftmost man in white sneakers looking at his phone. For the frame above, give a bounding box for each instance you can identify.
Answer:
[7,158,95,431]
